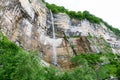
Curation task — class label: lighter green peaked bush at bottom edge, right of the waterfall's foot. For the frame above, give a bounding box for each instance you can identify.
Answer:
[62,59,97,80]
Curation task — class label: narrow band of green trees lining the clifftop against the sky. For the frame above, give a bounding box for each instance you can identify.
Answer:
[46,3,120,37]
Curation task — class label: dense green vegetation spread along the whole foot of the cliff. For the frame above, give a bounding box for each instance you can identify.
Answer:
[0,33,120,80]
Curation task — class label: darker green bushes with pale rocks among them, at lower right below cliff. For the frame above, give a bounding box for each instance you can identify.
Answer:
[71,53,120,80]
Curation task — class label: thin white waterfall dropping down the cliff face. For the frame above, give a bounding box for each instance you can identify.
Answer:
[50,10,58,66]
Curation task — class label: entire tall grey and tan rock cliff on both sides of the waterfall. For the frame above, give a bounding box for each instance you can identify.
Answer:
[0,0,120,67]
